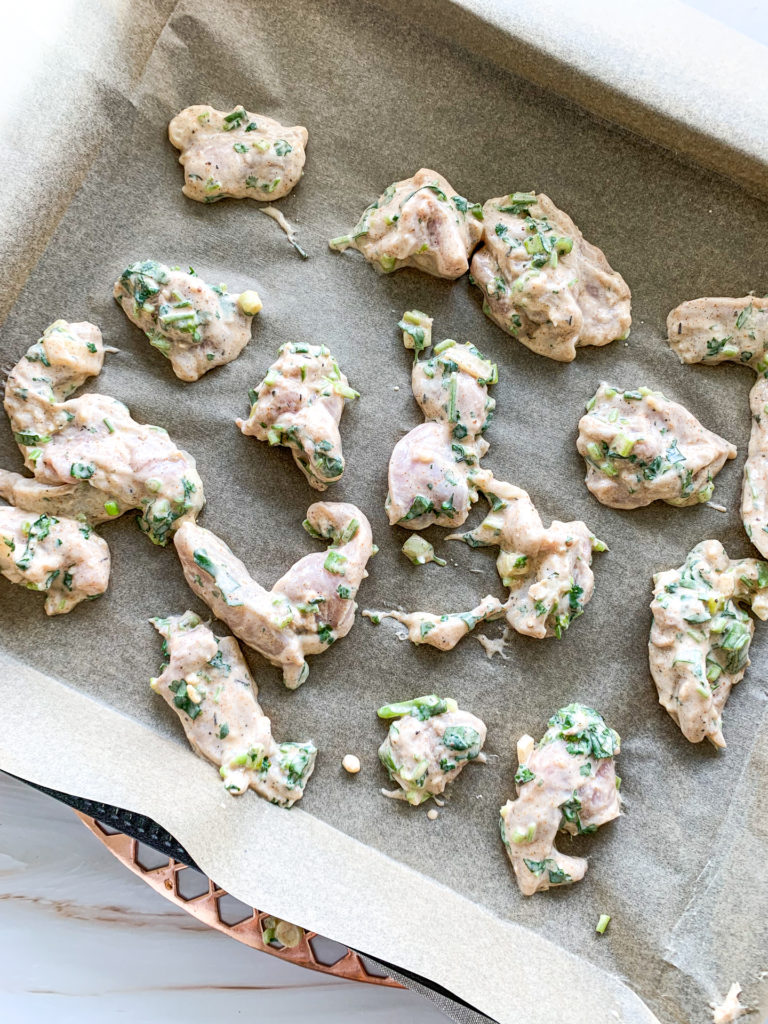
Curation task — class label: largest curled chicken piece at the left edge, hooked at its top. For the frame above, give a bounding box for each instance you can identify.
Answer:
[3,321,205,545]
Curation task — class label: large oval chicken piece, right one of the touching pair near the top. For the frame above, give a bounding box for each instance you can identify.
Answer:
[470,193,631,362]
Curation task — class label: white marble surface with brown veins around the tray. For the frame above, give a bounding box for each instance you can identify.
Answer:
[0,0,768,1024]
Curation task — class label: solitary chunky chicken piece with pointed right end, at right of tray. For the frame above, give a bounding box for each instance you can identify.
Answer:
[577,382,736,509]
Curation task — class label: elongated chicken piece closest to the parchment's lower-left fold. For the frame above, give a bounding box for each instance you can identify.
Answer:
[150,611,317,807]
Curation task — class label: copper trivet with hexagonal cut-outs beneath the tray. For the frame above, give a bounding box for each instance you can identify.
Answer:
[75,810,403,988]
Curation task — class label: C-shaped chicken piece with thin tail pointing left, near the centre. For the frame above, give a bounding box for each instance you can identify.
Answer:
[364,473,605,650]
